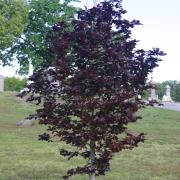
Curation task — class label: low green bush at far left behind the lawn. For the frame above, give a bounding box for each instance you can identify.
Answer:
[4,77,27,91]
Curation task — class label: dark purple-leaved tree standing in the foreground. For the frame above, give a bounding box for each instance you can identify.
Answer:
[21,0,164,180]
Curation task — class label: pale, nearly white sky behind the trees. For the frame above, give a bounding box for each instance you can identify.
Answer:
[0,0,180,82]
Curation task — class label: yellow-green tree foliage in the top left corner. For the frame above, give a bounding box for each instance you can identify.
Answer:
[0,0,27,60]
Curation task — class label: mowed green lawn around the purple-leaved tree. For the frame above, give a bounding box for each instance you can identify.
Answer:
[0,92,180,180]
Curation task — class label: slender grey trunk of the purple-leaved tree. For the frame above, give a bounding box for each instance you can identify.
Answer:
[89,141,95,180]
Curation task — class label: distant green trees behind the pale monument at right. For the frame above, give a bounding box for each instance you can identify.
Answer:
[156,81,180,102]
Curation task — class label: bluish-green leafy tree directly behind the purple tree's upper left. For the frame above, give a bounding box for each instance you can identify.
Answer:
[3,0,76,74]
